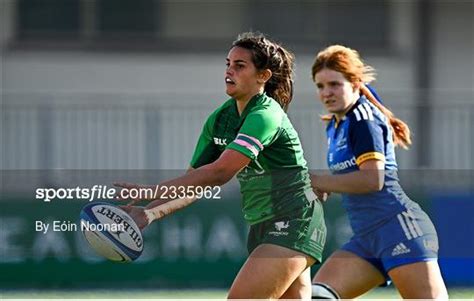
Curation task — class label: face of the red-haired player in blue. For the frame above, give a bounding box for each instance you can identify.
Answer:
[314,68,359,117]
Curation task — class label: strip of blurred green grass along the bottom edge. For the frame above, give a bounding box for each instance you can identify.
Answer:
[0,288,474,300]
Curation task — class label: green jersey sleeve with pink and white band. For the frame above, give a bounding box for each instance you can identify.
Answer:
[227,110,281,160]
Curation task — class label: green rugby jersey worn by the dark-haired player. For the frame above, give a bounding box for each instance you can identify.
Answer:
[191,93,316,224]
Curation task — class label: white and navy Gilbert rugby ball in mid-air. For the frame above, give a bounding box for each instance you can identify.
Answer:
[80,202,143,262]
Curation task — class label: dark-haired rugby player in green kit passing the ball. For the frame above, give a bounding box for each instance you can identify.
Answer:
[116,33,326,299]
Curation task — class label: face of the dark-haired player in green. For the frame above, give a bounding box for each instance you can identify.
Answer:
[225,47,265,101]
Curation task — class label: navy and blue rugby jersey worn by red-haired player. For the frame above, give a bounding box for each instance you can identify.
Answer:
[326,96,418,234]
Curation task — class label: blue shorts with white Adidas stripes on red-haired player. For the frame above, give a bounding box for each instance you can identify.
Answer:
[341,208,438,280]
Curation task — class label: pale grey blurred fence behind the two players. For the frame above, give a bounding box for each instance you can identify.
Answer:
[2,92,474,170]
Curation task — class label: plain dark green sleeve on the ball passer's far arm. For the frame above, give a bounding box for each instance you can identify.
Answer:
[190,114,220,168]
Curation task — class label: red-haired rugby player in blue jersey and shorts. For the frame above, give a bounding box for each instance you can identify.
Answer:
[311,45,448,299]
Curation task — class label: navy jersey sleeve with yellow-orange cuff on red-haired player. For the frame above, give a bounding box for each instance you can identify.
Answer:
[349,119,385,166]
